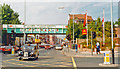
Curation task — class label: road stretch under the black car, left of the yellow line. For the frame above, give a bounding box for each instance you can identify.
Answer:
[2,49,72,67]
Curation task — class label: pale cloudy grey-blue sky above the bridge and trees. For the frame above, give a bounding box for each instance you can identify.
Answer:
[0,0,118,24]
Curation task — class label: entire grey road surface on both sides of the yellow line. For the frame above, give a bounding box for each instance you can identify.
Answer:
[2,48,118,68]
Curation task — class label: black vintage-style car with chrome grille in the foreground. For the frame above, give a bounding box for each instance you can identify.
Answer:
[18,44,39,60]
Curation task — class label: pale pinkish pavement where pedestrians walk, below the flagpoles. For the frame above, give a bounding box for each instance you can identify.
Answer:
[64,48,120,57]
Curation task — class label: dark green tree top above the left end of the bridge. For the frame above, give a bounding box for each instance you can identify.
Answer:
[0,4,21,24]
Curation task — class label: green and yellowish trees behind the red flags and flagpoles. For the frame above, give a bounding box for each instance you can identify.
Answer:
[66,17,117,48]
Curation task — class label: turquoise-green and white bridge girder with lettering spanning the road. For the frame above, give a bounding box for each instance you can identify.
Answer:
[3,24,67,34]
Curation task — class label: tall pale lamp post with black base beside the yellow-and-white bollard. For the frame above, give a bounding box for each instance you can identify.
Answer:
[111,0,114,64]
